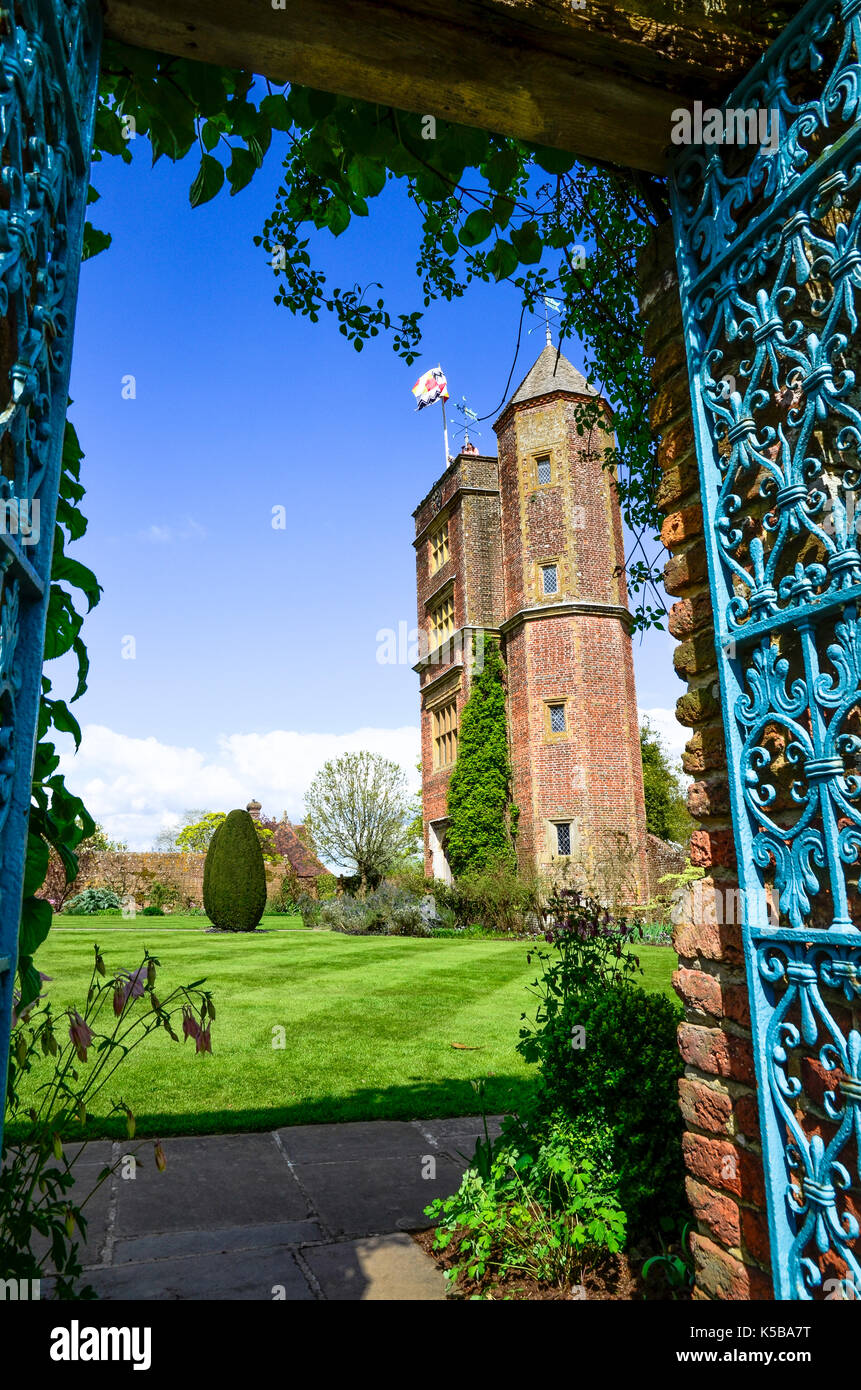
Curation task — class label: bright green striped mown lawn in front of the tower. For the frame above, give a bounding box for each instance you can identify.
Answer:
[13,916,676,1137]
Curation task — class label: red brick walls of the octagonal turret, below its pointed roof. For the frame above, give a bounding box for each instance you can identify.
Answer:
[497,392,647,897]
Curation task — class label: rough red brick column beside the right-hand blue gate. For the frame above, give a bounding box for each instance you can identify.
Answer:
[640,222,772,1298]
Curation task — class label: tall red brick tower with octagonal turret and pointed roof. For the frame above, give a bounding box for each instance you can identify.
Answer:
[415,342,647,899]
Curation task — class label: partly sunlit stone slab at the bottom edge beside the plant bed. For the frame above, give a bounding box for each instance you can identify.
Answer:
[303,1234,445,1302]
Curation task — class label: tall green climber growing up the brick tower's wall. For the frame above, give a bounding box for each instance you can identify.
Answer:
[445,635,515,877]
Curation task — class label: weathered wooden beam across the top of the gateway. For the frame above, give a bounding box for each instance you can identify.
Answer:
[104,0,801,172]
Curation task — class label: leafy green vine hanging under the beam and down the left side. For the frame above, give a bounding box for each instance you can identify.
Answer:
[19,42,666,1005]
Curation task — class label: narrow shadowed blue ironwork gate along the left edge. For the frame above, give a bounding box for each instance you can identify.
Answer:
[0,0,100,1129]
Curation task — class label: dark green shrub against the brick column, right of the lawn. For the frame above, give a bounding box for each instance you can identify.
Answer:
[517,892,684,1233]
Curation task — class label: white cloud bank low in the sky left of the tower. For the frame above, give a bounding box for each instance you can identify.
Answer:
[60,724,419,849]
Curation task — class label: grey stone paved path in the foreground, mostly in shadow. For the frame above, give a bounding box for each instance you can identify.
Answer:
[60,1116,499,1301]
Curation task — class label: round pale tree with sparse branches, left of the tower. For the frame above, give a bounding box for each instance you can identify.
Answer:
[305,752,412,892]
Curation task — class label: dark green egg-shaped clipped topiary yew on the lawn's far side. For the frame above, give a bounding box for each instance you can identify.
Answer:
[203,810,266,931]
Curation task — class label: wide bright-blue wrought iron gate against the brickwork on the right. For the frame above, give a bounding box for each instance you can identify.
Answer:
[672,0,861,1300]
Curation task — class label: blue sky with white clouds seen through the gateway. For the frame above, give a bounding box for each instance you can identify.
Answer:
[51,132,683,848]
